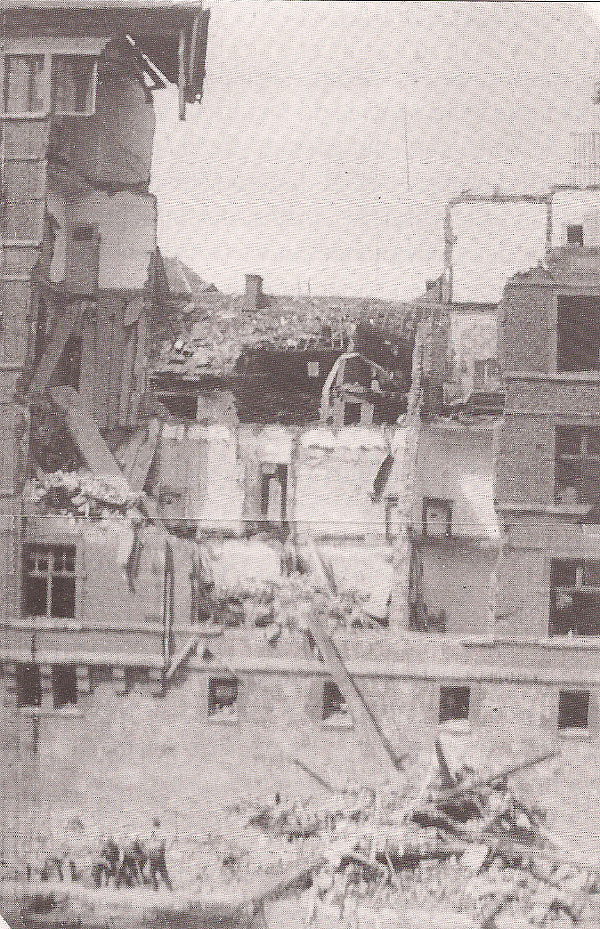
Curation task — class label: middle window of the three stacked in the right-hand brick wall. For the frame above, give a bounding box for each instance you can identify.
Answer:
[554,426,600,506]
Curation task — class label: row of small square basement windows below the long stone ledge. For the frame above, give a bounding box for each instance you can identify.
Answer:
[17,664,590,729]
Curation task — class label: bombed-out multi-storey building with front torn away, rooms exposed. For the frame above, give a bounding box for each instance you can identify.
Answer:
[0,4,600,848]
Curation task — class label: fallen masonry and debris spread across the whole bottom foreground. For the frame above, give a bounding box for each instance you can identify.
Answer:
[0,742,600,929]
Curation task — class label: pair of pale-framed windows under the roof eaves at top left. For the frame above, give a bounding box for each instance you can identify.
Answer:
[3,55,96,116]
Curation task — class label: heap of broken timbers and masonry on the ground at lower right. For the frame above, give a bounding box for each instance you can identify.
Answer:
[229,746,600,929]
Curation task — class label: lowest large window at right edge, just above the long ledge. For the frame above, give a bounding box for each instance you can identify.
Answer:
[548,560,600,636]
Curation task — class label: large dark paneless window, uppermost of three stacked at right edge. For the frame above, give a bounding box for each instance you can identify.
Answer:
[556,294,600,371]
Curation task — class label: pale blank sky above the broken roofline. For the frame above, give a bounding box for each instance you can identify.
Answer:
[153,0,600,299]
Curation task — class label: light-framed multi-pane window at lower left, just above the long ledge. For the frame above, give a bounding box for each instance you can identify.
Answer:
[23,544,75,619]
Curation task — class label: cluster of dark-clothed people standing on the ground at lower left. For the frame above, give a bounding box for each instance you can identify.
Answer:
[92,819,173,890]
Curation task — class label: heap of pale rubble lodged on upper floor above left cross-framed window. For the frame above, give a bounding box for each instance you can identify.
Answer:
[27,471,142,520]
